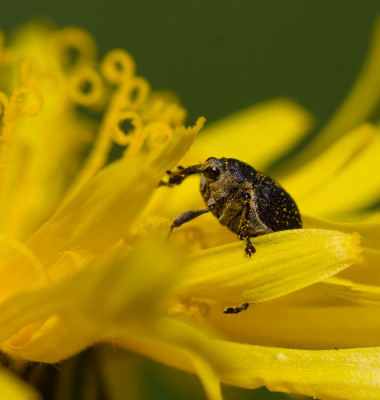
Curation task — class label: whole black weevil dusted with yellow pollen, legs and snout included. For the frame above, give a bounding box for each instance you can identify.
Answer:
[161,157,302,314]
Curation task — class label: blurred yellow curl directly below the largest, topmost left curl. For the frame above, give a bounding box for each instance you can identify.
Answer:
[68,68,104,106]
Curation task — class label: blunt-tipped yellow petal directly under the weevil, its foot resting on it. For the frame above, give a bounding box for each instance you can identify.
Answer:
[179,229,361,303]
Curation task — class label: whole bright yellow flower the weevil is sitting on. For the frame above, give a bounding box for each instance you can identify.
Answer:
[0,21,380,399]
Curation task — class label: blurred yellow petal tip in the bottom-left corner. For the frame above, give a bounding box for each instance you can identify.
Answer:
[0,368,41,400]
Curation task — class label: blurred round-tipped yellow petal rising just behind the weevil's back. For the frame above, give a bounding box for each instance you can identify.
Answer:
[183,99,311,169]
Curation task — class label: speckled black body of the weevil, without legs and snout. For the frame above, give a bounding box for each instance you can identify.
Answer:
[200,158,302,239]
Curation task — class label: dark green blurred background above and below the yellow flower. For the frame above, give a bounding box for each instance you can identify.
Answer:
[0,0,380,400]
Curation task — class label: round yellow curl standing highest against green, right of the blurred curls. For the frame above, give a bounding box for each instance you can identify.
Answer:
[101,49,136,84]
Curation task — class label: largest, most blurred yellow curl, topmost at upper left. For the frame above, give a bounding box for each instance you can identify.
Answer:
[56,28,97,69]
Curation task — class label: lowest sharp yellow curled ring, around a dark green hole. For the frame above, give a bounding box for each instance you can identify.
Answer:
[113,110,145,154]
